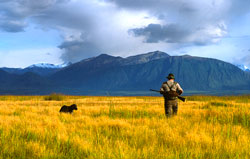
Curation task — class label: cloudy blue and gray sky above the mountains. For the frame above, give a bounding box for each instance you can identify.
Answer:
[0,0,250,67]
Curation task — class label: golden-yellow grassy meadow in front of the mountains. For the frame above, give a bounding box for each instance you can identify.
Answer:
[0,96,250,159]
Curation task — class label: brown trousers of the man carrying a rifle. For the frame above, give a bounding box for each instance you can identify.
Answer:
[164,98,178,117]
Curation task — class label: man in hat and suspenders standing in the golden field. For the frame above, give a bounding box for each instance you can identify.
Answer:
[160,73,183,117]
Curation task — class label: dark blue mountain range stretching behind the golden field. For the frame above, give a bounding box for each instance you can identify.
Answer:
[0,51,250,95]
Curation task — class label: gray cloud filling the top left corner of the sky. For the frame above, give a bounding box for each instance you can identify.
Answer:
[0,0,67,32]
